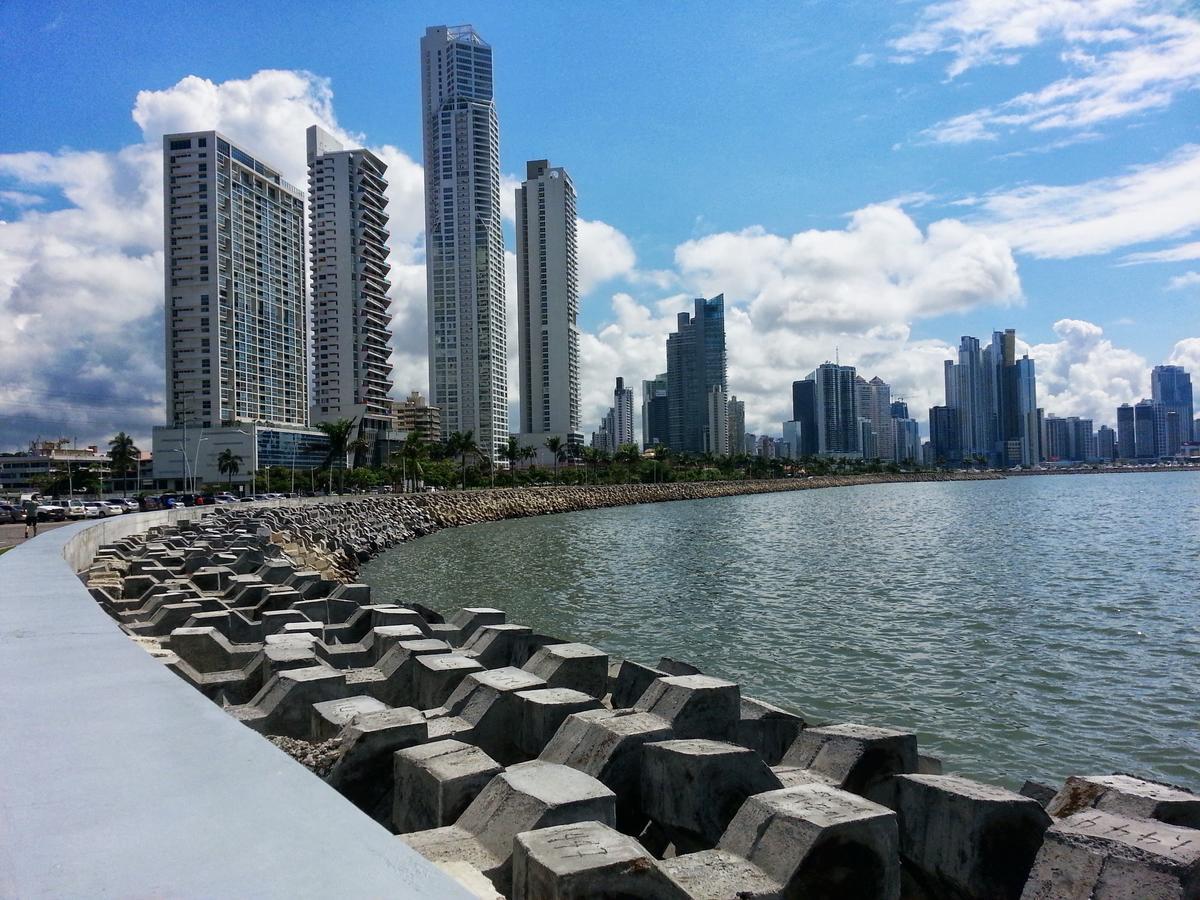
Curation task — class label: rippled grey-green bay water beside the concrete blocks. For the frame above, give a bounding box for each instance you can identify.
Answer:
[362,473,1200,790]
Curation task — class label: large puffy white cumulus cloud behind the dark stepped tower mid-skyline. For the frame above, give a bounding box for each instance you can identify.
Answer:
[573,205,1020,434]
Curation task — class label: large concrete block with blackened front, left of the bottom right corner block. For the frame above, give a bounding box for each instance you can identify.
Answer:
[896,775,1050,900]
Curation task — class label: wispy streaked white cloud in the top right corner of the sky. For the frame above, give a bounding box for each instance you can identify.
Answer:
[893,0,1200,143]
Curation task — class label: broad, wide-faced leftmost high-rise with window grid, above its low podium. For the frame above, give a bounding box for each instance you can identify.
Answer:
[162,131,308,427]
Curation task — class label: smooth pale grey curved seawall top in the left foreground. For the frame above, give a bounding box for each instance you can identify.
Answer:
[0,504,468,898]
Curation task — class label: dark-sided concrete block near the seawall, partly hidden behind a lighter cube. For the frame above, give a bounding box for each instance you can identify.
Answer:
[325,707,428,823]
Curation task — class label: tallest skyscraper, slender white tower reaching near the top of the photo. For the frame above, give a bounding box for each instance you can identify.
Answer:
[421,25,509,458]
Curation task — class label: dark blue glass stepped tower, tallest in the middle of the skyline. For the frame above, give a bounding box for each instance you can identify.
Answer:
[667,294,727,454]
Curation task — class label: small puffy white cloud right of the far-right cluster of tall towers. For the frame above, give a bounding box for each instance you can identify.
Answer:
[1030,319,1150,427]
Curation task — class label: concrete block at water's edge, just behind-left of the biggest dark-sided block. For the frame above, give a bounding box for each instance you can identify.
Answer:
[781,724,918,809]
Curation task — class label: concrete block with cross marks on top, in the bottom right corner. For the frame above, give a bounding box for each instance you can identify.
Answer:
[1021,810,1200,900]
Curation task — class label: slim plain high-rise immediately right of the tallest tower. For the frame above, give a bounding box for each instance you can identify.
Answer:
[516,160,583,445]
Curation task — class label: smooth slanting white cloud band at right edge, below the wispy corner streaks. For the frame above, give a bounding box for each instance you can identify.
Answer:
[971,144,1200,256]
